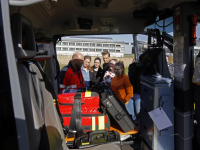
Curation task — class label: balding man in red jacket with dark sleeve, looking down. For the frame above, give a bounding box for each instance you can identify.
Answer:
[58,52,85,91]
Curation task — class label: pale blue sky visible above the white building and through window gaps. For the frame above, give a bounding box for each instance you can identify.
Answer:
[68,24,200,43]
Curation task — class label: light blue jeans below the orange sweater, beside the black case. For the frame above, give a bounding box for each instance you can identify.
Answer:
[125,98,141,120]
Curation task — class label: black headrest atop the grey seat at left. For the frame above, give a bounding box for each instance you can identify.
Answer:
[11,14,36,59]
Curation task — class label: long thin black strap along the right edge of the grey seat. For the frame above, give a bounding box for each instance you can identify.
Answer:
[32,60,65,129]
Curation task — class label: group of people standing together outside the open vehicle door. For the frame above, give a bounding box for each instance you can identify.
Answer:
[59,52,140,123]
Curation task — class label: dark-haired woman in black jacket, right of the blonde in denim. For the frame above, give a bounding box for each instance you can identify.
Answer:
[92,57,103,83]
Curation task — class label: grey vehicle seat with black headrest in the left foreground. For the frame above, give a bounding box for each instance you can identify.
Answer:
[11,14,68,150]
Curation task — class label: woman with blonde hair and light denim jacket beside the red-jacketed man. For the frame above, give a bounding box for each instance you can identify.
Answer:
[81,55,95,87]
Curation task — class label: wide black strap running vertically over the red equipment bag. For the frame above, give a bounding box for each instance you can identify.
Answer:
[68,92,85,138]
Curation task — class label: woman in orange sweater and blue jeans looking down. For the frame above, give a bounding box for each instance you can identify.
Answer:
[110,61,134,119]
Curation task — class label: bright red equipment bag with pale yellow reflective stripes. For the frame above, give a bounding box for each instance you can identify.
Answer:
[58,91,110,132]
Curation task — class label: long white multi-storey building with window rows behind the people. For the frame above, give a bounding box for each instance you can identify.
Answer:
[56,37,125,57]
